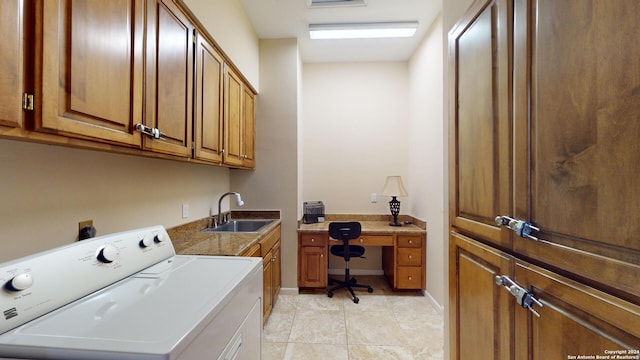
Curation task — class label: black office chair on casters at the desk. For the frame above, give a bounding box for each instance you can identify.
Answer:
[327,221,373,304]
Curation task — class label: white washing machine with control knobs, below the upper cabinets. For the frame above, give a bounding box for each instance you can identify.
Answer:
[0,226,262,360]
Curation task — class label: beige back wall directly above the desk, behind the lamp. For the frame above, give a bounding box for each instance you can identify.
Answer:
[302,63,412,214]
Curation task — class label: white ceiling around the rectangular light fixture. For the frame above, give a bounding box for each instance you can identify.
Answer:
[240,0,442,63]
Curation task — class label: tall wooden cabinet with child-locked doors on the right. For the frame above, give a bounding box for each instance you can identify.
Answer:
[449,0,640,359]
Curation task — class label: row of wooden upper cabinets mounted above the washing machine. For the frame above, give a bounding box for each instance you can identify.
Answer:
[0,0,255,168]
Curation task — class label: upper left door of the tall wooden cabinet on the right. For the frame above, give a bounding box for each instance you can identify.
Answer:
[449,0,511,247]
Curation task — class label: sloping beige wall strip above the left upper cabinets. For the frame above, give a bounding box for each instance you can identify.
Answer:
[182,0,260,91]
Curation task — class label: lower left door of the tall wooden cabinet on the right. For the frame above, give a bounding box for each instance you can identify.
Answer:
[449,233,525,360]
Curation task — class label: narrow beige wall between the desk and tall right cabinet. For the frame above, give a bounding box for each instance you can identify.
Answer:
[407,17,447,306]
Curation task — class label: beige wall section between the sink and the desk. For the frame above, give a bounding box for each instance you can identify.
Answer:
[231,39,299,288]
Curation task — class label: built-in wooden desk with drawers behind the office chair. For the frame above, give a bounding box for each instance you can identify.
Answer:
[298,219,427,289]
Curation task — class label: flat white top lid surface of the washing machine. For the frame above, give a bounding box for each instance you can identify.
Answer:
[0,256,262,359]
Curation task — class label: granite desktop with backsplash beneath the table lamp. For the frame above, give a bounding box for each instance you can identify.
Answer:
[298,215,426,234]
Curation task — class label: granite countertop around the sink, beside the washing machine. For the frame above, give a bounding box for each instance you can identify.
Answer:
[167,210,280,256]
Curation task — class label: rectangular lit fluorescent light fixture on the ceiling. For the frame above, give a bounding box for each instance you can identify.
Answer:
[309,21,418,39]
